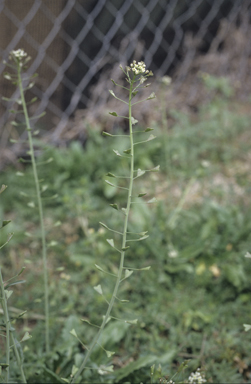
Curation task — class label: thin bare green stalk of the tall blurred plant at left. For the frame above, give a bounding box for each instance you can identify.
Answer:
[17,65,50,352]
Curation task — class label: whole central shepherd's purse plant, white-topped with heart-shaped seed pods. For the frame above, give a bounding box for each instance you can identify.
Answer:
[67,61,159,383]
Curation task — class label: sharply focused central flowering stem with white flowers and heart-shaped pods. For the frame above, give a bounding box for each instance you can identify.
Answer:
[71,61,158,383]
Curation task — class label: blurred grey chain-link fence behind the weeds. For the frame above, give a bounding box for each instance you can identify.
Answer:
[0,0,251,154]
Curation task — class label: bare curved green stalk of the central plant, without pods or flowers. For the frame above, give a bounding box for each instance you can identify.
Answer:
[71,77,134,383]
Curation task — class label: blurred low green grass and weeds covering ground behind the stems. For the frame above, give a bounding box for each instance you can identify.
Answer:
[0,91,251,383]
